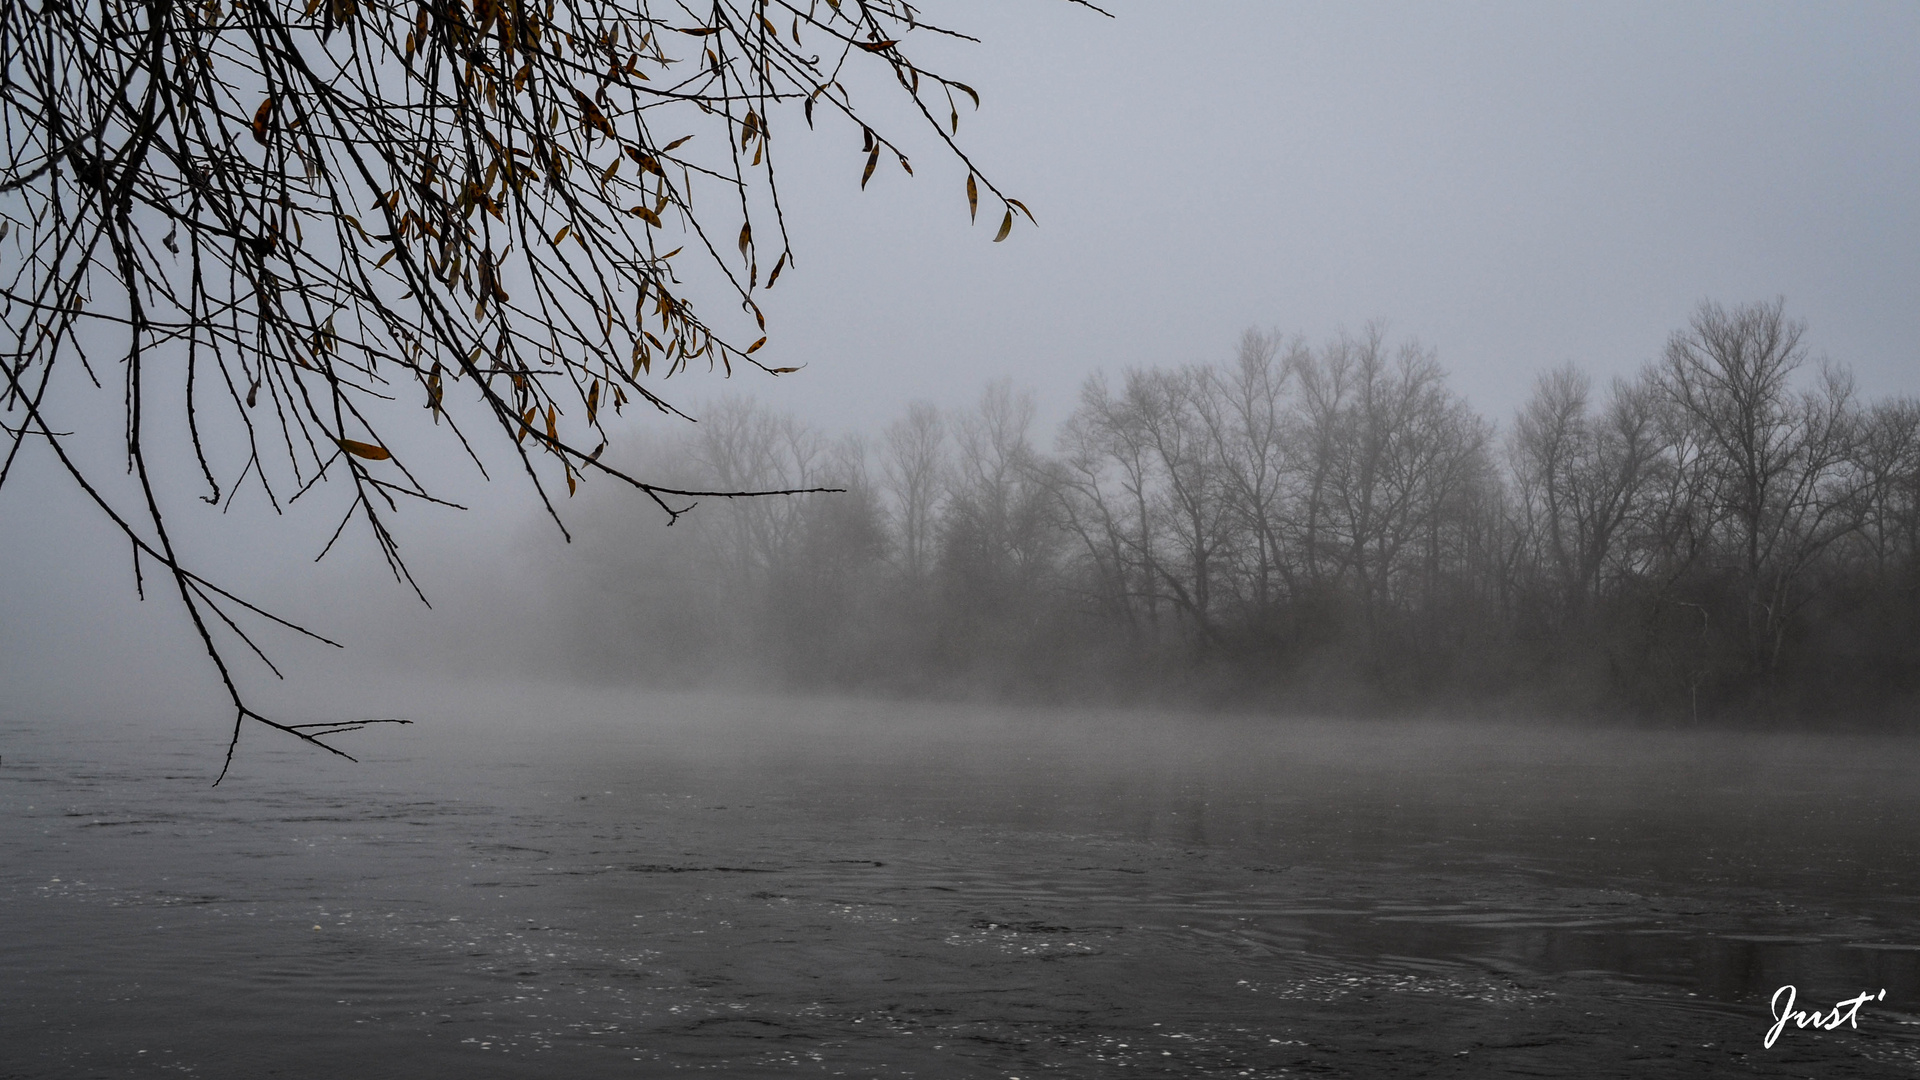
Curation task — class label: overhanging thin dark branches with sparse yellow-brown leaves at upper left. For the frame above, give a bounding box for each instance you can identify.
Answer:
[0,0,1082,761]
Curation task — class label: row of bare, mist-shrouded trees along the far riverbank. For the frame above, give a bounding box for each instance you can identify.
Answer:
[568,302,1920,723]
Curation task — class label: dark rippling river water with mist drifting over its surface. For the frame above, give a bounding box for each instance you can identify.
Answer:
[0,690,1920,1080]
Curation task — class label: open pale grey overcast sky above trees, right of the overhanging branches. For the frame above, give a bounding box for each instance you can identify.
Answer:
[743,0,1920,427]
